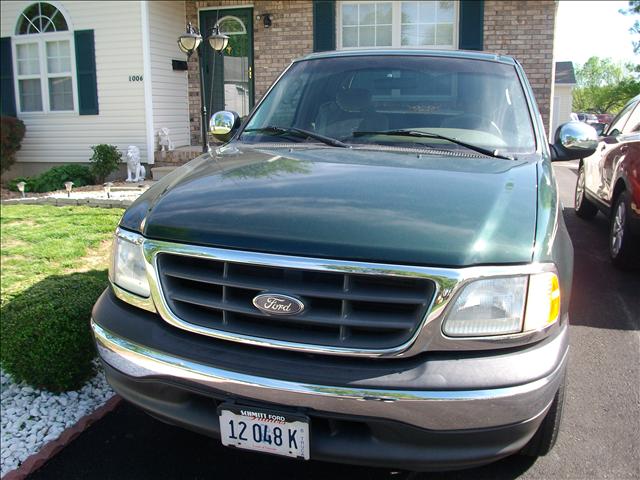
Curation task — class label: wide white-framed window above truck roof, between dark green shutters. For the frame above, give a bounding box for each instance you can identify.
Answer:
[338,0,458,49]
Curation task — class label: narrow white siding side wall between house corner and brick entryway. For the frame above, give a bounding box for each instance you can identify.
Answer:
[149,1,190,147]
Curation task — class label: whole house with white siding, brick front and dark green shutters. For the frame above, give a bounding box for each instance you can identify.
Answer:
[0,0,556,178]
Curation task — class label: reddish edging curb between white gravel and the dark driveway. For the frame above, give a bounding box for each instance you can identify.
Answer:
[2,395,122,480]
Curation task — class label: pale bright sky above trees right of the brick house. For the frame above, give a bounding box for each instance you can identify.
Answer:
[554,0,640,64]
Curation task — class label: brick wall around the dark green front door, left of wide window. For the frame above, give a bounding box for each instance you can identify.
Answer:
[185,0,313,145]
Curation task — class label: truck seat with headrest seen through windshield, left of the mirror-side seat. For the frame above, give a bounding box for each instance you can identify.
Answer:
[315,88,389,138]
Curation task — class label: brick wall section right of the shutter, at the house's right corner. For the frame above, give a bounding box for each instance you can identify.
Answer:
[484,0,556,136]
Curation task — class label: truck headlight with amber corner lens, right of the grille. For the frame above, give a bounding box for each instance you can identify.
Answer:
[442,272,560,337]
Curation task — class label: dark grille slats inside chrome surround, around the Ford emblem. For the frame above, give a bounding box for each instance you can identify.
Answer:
[156,252,435,350]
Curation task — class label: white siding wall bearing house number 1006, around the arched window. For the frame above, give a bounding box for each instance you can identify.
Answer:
[0,0,149,163]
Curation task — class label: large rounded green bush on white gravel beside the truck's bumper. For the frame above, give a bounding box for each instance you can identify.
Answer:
[0,270,107,392]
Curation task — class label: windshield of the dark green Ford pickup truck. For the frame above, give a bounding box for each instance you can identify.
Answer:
[240,55,535,153]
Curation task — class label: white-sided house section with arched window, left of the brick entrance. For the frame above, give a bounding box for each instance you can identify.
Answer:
[0,0,189,178]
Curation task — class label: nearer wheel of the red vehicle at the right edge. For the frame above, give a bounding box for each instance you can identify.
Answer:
[609,191,638,268]
